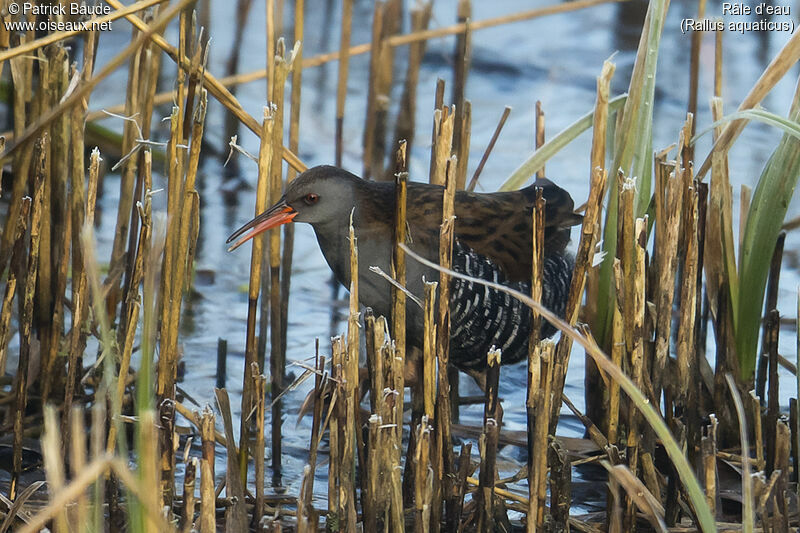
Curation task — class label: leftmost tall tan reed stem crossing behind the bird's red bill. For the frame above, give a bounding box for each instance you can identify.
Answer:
[239,106,275,475]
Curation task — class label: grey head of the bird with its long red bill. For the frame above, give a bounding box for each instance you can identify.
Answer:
[227,166,358,252]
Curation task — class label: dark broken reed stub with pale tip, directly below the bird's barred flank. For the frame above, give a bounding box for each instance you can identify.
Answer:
[476,350,501,533]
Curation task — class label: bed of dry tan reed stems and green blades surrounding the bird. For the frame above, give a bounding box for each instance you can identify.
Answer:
[0,0,800,533]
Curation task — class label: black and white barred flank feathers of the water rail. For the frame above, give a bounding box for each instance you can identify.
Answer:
[450,240,574,370]
